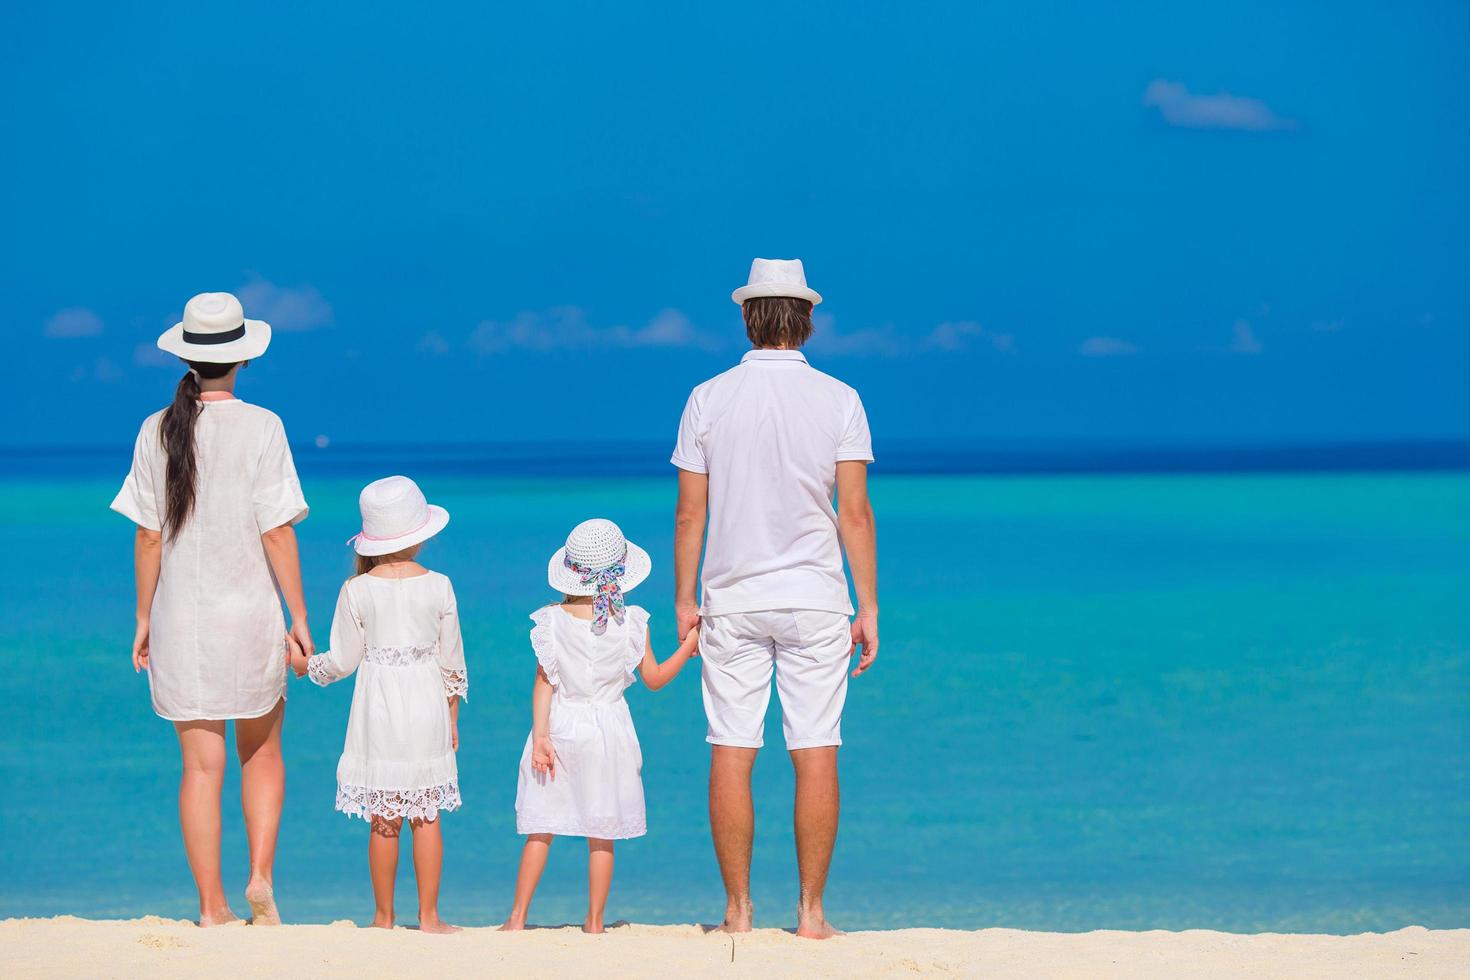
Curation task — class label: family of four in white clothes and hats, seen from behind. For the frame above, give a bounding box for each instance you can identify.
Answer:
[112,259,878,939]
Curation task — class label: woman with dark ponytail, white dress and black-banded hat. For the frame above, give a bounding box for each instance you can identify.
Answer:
[112,292,315,926]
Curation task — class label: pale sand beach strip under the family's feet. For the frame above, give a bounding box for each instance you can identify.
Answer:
[0,915,1470,980]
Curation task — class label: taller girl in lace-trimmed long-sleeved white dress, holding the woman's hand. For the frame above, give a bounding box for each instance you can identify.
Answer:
[291,476,469,933]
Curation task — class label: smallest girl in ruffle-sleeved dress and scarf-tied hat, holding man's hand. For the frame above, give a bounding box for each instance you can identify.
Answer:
[503,520,700,933]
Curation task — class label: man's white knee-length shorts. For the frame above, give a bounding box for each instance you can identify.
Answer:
[700,610,853,749]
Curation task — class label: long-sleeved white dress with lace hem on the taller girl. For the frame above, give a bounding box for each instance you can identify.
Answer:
[307,572,469,820]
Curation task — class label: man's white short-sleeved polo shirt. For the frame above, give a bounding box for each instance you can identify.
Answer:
[670,350,873,616]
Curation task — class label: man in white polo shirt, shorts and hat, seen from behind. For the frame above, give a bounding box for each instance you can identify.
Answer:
[672,259,878,939]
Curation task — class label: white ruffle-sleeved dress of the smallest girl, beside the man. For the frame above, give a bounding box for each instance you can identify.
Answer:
[516,605,648,840]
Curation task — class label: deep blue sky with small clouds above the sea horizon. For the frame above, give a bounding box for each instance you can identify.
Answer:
[0,1,1470,447]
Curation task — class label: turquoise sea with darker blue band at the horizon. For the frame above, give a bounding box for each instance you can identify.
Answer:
[0,450,1470,933]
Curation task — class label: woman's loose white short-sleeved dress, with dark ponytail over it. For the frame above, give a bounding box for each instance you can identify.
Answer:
[112,398,307,721]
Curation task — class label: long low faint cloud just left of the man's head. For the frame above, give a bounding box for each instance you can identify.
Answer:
[469,306,722,354]
